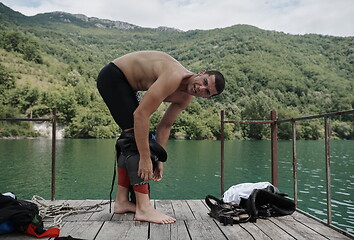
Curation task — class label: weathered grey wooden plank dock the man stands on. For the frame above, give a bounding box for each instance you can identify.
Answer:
[0,200,352,240]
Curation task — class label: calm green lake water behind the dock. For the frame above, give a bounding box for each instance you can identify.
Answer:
[0,139,354,233]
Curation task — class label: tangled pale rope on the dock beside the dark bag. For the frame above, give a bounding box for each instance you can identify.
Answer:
[32,195,109,228]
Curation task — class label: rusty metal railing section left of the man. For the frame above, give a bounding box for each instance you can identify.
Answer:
[0,108,57,201]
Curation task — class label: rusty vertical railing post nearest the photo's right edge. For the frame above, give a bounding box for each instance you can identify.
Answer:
[324,117,332,224]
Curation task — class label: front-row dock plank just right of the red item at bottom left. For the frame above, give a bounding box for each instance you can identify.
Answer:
[60,221,103,239]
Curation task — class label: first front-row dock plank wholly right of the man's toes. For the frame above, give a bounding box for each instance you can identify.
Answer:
[185,219,226,240]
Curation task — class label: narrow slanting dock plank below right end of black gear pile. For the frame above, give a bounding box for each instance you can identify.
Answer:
[254,219,295,240]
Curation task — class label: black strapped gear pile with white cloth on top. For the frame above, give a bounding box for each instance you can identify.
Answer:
[205,182,295,225]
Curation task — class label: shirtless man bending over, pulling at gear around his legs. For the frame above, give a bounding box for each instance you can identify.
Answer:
[97,51,225,224]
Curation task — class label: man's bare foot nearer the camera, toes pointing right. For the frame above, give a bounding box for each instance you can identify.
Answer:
[135,206,176,224]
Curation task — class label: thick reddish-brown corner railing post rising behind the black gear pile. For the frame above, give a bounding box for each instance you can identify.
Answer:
[270,110,278,187]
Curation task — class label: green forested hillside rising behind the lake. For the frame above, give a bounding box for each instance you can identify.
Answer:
[0,3,354,139]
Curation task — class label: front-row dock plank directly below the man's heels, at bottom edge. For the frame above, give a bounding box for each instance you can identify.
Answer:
[96,221,149,240]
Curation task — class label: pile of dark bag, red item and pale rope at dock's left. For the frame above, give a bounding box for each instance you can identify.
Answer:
[0,193,109,240]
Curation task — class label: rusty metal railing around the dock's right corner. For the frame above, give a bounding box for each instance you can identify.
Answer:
[220,109,354,232]
